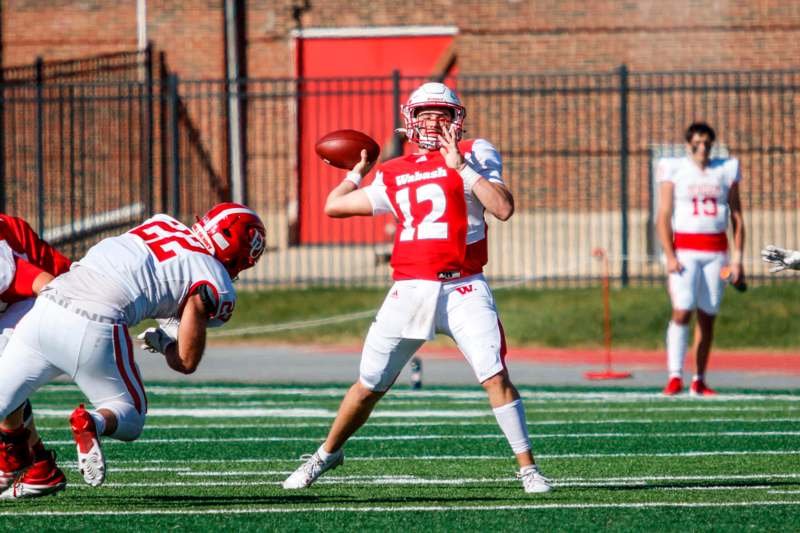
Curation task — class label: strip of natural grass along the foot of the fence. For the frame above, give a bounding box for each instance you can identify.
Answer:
[211,283,800,350]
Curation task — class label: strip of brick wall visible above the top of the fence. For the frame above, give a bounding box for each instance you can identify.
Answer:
[2,0,800,78]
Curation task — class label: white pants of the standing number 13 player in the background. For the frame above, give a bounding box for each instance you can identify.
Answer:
[667,250,728,315]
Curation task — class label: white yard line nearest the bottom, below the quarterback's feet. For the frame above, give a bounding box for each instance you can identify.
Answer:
[0,500,800,517]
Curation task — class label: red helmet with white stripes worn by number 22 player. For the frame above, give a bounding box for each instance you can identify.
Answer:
[192,202,267,278]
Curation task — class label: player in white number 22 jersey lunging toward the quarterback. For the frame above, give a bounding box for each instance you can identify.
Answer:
[0,203,265,494]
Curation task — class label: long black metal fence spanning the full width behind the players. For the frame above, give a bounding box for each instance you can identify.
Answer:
[0,58,800,285]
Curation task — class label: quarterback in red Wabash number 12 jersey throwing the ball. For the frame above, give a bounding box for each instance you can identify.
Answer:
[283,83,551,492]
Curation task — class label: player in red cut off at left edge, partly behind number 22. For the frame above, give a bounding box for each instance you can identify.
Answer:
[0,214,72,499]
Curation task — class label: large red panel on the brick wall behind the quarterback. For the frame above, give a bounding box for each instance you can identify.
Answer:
[297,35,453,244]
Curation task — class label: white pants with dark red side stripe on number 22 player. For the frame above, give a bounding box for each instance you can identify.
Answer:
[0,297,147,422]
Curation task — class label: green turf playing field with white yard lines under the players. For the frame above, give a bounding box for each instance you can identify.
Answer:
[0,384,800,531]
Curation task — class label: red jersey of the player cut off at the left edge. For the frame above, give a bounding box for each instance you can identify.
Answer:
[0,214,72,303]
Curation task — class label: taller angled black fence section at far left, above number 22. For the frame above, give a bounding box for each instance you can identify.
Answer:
[0,48,228,257]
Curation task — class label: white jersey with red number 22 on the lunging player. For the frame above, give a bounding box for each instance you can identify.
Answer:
[42,214,236,326]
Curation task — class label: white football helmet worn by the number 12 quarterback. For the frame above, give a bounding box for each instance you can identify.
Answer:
[400,82,467,150]
